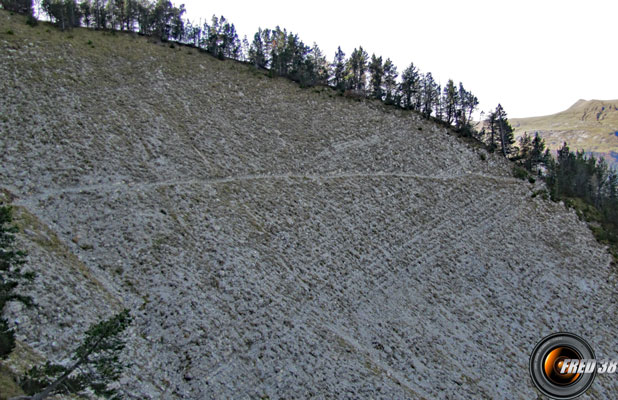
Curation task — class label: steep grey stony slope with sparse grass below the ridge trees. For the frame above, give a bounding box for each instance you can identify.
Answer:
[0,13,618,399]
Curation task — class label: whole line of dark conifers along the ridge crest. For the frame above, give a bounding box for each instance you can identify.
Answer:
[0,0,618,254]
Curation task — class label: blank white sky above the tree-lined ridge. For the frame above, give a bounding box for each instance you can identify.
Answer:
[180,0,618,117]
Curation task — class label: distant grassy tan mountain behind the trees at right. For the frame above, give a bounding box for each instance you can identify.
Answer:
[510,100,618,165]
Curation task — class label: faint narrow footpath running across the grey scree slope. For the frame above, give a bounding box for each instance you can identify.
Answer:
[14,172,522,201]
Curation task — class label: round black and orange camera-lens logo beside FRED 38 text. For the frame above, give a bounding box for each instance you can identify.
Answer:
[530,332,596,400]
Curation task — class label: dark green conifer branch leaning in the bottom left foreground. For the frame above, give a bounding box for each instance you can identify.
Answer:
[20,309,132,399]
